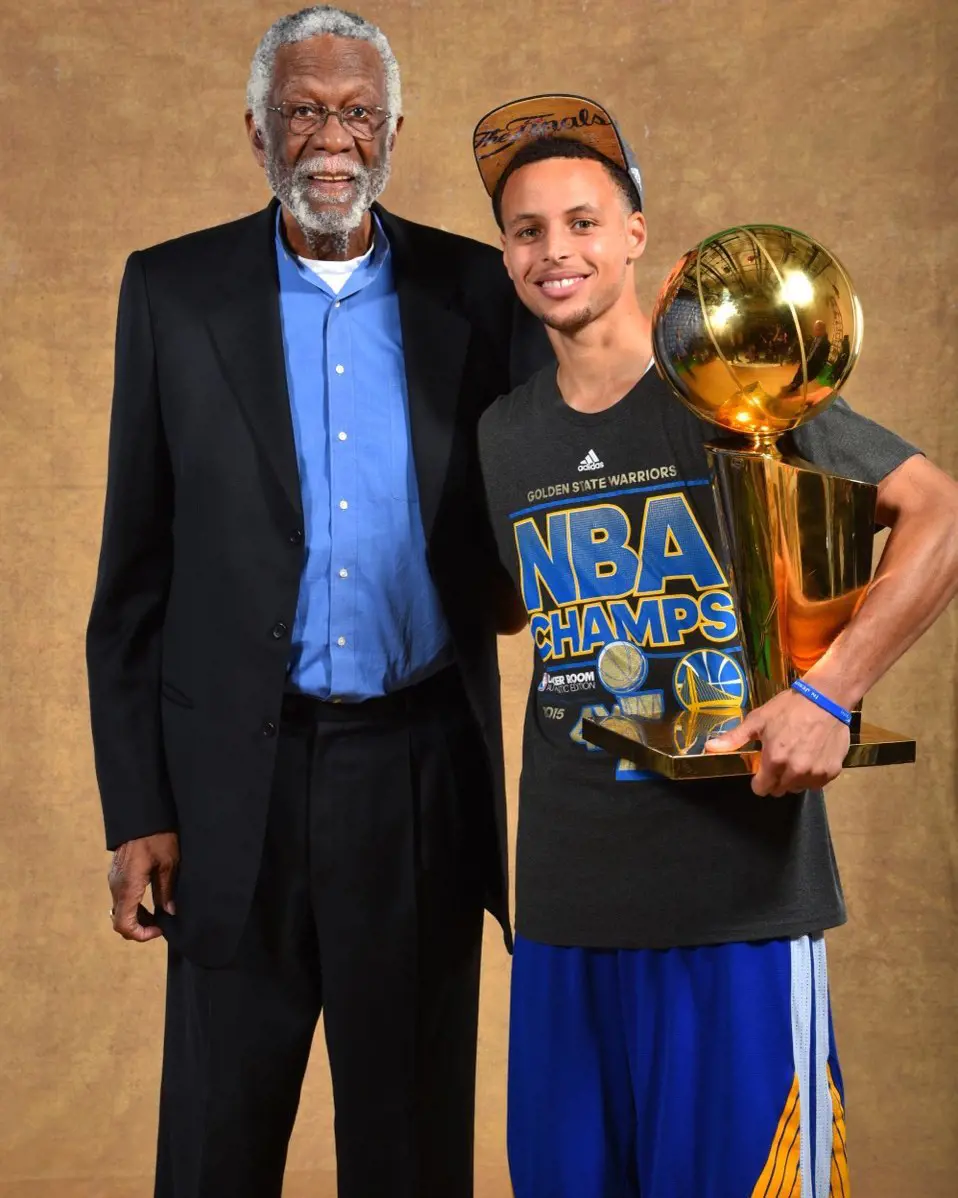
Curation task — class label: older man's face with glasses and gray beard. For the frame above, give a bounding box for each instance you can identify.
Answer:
[247,35,402,251]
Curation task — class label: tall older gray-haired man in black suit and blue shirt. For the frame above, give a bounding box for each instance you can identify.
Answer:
[87,6,548,1198]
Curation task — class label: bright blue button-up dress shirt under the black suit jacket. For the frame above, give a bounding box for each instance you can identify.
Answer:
[275,213,451,702]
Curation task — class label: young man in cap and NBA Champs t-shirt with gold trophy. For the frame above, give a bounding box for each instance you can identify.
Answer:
[474,96,958,1198]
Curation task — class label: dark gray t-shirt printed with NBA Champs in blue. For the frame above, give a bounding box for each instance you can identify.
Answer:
[479,365,917,948]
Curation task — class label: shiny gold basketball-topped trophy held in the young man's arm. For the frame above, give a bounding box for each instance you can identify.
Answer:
[582,225,915,779]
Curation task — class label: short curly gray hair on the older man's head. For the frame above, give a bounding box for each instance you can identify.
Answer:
[247,4,402,133]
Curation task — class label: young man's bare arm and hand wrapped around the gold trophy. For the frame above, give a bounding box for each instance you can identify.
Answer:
[709,454,958,795]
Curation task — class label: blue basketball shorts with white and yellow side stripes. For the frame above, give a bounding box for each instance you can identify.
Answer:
[508,936,850,1198]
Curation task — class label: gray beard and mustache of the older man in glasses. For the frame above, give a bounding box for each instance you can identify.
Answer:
[266,144,392,254]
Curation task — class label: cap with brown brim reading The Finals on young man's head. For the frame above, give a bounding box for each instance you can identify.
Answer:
[473,95,644,212]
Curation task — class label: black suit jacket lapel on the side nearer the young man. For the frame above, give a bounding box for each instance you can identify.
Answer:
[376,206,471,539]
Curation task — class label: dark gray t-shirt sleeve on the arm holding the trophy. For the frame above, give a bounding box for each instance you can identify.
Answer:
[792,398,921,483]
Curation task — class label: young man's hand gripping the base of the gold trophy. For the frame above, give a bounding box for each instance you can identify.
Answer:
[705,690,850,798]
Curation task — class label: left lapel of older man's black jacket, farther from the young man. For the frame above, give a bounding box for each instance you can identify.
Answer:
[207,204,303,516]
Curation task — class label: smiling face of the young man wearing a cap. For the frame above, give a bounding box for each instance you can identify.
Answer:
[502,158,645,335]
